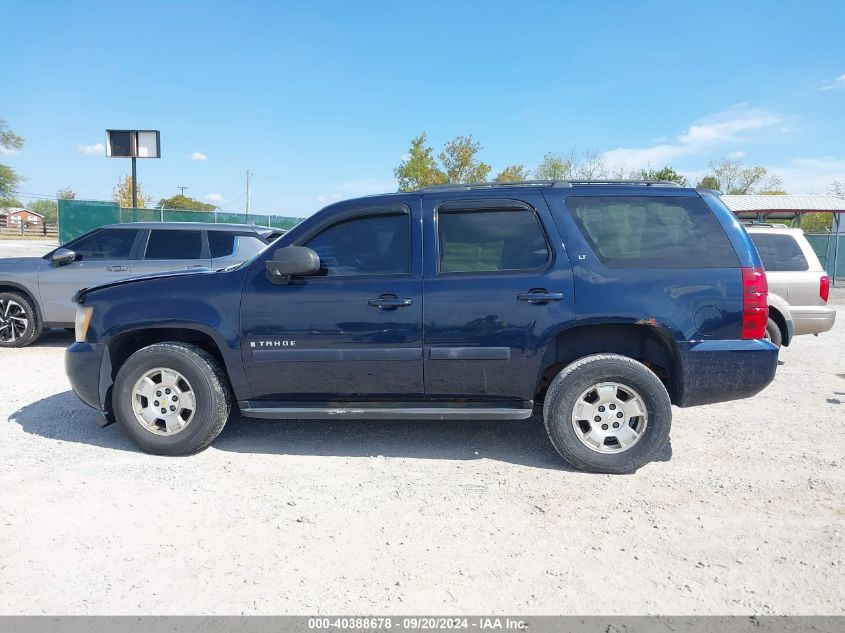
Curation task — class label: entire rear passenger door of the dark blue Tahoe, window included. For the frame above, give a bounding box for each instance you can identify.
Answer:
[423,191,574,400]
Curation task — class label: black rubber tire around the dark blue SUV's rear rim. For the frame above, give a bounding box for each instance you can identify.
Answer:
[543,354,672,474]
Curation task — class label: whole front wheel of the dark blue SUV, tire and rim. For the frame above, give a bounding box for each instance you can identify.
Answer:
[112,343,231,455]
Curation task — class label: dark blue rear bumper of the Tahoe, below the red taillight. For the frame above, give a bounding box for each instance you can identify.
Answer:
[675,340,778,407]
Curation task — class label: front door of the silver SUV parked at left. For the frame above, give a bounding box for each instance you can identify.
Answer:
[38,228,143,325]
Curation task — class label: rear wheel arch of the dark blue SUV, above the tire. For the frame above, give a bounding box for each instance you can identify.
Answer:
[534,323,681,404]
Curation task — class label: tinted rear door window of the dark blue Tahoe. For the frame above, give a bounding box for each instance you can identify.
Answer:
[437,209,549,273]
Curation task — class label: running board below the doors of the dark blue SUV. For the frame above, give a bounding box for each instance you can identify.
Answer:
[238,400,534,420]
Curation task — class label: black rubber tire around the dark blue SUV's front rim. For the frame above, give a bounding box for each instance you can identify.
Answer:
[112,343,232,455]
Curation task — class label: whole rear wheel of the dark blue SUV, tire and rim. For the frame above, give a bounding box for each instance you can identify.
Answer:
[543,354,672,474]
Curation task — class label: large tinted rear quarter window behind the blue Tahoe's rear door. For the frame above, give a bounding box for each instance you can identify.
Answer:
[566,196,739,268]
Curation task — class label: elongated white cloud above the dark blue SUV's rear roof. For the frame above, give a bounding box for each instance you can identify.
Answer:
[603,105,783,169]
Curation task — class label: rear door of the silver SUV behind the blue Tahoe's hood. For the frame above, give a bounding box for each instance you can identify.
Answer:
[132,228,211,277]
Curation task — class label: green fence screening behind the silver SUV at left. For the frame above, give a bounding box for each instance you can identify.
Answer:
[59,200,302,244]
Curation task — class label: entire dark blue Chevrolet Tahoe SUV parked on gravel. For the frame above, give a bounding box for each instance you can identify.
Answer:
[66,181,777,473]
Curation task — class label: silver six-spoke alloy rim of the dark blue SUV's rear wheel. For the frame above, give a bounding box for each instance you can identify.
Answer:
[572,382,648,453]
